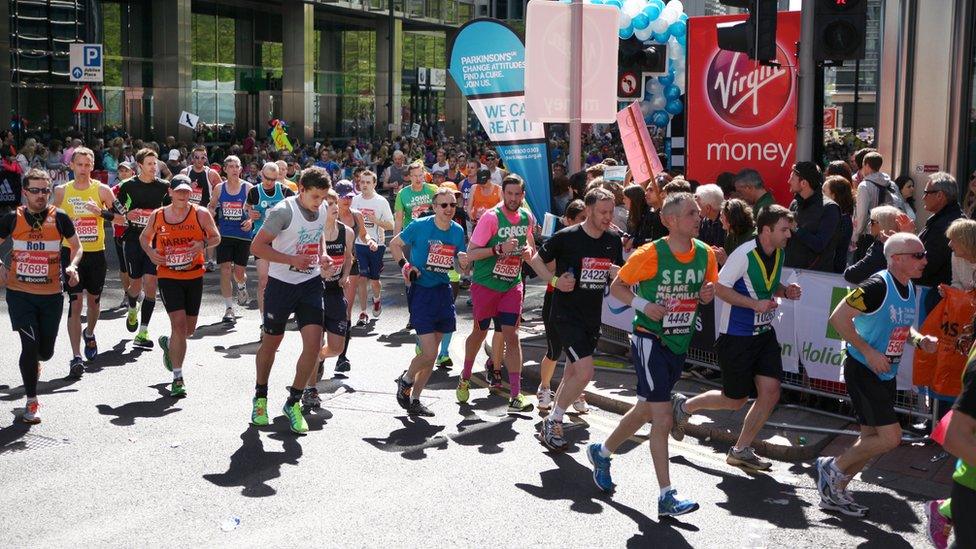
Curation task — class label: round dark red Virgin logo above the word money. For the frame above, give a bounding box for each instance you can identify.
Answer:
[705,48,793,128]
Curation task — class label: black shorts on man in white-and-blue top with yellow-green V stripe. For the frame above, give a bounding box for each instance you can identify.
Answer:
[715,329,783,399]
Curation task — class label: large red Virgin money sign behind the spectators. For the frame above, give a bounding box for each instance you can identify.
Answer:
[685,12,800,210]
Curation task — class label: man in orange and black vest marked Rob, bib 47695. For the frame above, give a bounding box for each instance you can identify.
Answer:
[0,168,84,424]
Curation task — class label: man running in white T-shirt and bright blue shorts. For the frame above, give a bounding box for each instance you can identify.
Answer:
[352,170,394,321]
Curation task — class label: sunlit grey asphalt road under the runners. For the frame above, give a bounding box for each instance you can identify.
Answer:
[0,246,928,549]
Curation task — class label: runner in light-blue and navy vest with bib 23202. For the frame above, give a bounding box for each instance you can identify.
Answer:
[209,155,254,322]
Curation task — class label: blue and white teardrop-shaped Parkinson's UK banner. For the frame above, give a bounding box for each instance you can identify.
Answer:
[449,19,550,220]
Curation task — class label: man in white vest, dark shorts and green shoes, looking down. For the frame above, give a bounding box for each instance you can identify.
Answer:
[251,168,331,434]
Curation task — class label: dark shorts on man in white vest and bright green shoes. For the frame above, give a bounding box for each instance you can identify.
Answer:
[263,276,324,335]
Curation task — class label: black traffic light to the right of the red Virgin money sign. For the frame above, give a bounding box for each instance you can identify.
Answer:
[813,0,868,61]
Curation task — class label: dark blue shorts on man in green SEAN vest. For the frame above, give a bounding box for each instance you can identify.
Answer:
[630,331,685,402]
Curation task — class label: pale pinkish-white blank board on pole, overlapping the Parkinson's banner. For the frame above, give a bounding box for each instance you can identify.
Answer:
[525,0,619,124]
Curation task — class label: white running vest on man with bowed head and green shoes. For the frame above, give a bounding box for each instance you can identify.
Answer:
[268,196,329,284]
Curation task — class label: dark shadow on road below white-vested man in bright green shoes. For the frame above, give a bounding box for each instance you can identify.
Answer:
[203,424,302,498]
